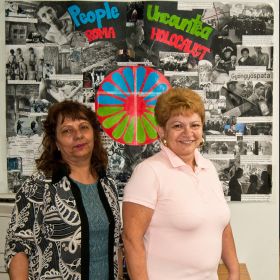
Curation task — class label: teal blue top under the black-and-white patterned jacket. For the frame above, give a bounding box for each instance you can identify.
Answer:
[75,181,109,280]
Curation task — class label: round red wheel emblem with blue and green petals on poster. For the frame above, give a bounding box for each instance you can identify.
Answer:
[95,66,170,145]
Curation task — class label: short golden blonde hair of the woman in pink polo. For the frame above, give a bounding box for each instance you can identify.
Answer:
[155,88,205,127]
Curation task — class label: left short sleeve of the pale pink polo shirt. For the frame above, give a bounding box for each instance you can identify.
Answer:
[123,161,159,209]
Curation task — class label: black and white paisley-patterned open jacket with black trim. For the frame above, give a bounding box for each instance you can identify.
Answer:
[5,167,121,280]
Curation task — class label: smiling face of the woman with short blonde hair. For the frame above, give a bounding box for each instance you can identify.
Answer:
[159,111,203,162]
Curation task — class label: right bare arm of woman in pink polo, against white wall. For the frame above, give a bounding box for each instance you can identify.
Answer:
[222,224,240,280]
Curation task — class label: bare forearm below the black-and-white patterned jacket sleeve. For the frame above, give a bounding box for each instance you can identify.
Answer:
[9,253,29,280]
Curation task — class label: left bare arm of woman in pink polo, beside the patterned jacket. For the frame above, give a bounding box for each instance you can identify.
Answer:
[123,202,154,280]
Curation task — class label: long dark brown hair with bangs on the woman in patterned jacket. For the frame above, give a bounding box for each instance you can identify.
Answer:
[36,100,108,176]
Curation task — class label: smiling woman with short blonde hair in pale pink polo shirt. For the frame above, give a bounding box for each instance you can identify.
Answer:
[123,88,239,280]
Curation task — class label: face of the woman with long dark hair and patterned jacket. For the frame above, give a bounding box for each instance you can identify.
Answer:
[56,116,94,165]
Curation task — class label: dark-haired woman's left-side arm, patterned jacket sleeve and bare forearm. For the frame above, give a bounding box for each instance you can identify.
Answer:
[4,175,42,280]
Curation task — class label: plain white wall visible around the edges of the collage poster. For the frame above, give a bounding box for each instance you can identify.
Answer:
[0,0,279,280]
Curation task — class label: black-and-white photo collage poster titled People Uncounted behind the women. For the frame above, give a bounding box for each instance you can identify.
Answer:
[4,1,274,202]
